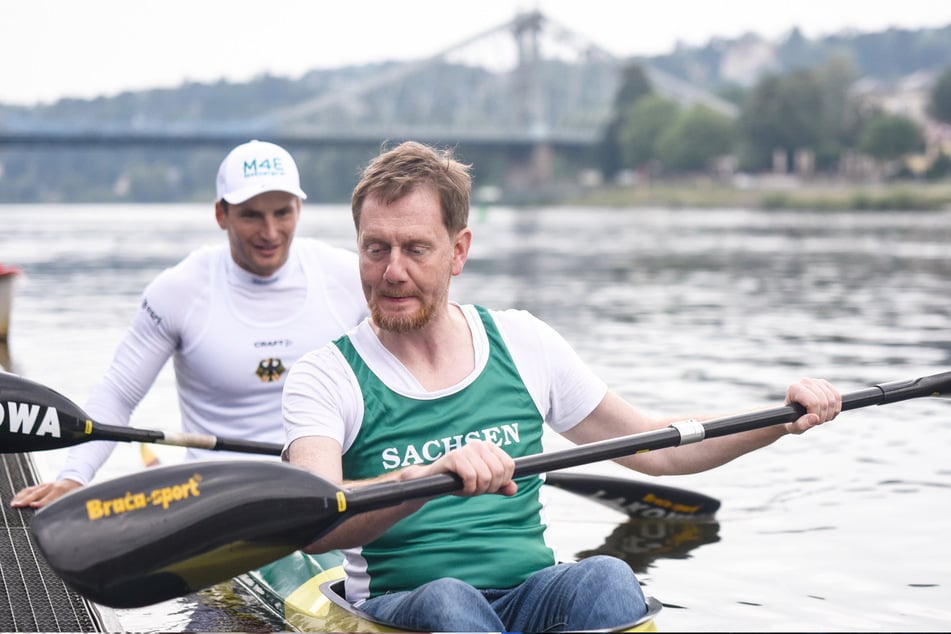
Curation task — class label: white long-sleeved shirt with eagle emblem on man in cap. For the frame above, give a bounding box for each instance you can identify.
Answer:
[59,238,367,483]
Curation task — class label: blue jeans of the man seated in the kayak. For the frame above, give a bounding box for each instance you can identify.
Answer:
[360,555,647,632]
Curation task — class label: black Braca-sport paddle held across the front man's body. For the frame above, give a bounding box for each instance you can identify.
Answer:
[31,372,951,608]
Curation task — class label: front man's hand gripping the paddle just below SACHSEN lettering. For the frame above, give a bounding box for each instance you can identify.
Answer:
[403,440,518,496]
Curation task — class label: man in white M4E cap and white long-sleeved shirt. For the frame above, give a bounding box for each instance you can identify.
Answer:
[13,141,367,508]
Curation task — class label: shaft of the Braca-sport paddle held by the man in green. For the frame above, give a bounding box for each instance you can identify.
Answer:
[342,372,951,512]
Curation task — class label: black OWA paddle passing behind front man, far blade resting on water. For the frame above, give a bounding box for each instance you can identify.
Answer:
[0,373,720,519]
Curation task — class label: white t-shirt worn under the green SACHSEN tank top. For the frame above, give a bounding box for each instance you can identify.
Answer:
[283,305,607,451]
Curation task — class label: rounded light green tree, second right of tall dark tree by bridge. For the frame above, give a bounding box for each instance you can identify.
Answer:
[657,106,736,172]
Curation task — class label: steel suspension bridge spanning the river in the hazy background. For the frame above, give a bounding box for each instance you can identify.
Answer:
[0,11,735,195]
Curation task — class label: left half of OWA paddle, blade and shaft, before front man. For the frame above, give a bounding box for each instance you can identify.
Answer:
[0,373,282,456]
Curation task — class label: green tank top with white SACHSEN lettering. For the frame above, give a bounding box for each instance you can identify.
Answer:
[334,307,555,596]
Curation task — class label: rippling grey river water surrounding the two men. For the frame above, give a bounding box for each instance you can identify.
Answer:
[0,205,951,631]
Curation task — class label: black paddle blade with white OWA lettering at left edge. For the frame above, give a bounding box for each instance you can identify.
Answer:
[0,372,89,453]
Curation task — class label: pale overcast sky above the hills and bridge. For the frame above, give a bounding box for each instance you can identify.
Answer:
[0,0,951,105]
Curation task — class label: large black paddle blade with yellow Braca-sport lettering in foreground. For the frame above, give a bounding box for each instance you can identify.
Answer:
[31,460,343,608]
